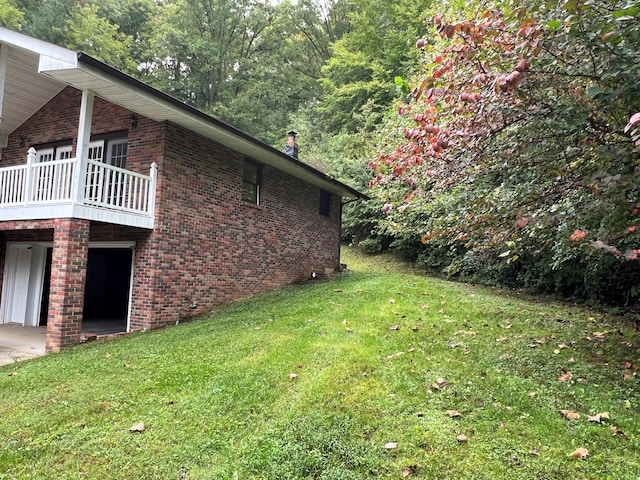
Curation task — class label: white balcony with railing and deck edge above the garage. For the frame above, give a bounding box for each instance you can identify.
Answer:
[0,151,157,229]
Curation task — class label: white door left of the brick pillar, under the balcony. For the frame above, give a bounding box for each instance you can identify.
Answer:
[1,244,46,327]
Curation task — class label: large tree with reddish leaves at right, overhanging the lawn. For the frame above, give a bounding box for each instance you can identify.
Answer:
[369,0,640,299]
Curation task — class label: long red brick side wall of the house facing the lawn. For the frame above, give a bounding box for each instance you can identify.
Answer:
[154,125,340,324]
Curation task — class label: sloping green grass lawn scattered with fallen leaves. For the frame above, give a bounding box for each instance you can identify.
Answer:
[0,249,640,480]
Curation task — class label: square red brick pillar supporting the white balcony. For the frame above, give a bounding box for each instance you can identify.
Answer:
[45,218,89,352]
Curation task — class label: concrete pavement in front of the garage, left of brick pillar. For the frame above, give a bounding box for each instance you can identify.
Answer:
[0,323,47,365]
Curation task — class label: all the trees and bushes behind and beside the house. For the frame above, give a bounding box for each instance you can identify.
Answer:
[0,0,640,306]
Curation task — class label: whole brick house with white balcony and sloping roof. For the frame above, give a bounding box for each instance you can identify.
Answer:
[0,28,366,351]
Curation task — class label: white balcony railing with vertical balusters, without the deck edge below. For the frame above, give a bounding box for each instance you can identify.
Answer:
[0,149,157,217]
